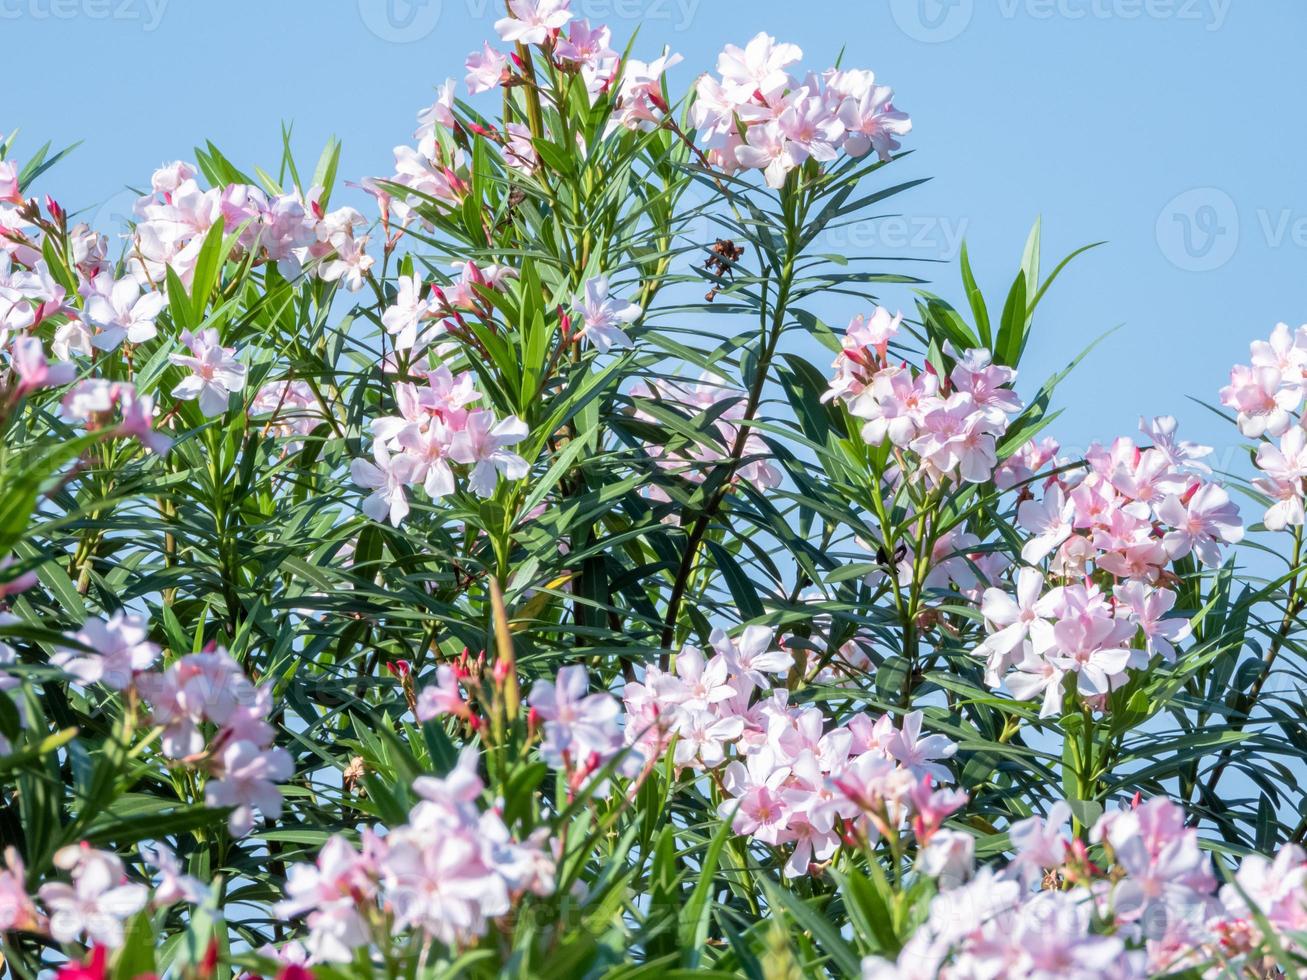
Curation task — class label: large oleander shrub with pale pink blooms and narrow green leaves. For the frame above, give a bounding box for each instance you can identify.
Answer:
[0,0,1307,980]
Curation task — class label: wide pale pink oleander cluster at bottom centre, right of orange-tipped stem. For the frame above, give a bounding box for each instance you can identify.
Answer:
[622,626,966,878]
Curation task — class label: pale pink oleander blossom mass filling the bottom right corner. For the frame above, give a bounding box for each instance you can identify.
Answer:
[863,797,1307,980]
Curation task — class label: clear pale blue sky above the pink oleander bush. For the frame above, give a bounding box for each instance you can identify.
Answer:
[0,0,1307,462]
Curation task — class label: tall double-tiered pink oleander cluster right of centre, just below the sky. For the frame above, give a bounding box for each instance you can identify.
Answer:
[975,417,1243,716]
